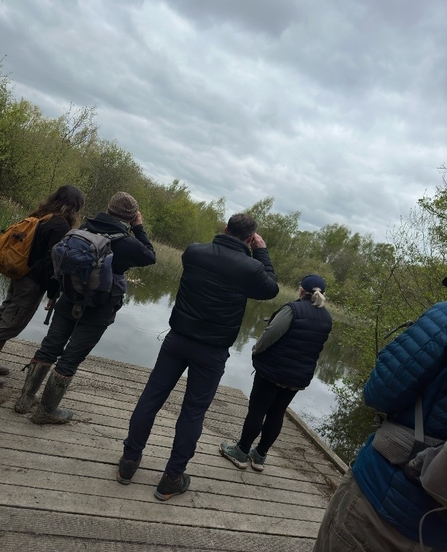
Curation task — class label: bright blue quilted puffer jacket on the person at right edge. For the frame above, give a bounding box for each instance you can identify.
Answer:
[353,302,447,550]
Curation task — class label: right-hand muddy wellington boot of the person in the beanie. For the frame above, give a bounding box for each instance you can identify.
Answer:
[31,370,73,424]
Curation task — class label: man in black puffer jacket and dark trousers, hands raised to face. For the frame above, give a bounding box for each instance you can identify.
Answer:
[117,214,279,500]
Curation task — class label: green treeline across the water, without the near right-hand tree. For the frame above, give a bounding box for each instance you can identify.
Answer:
[0,69,394,301]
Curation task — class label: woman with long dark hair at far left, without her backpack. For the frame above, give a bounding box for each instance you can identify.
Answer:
[0,184,84,387]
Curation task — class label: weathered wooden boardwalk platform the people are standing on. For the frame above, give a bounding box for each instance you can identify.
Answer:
[0,340,345,552]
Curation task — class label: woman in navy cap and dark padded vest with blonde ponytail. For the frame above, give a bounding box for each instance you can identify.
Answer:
[219,274,332,471]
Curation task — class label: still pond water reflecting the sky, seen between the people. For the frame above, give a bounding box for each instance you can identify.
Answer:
[0,272,345,438]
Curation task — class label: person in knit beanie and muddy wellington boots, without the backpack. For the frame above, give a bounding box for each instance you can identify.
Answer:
[14,192,155,424]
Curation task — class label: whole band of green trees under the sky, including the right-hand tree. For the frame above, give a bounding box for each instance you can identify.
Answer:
[0,67,447,457]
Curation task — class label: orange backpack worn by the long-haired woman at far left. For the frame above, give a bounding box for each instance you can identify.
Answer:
[0,215,53,280]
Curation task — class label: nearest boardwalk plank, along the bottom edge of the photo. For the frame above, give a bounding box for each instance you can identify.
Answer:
[0,506,313,552]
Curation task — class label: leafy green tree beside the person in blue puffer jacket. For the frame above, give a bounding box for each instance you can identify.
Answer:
[319,188,447,460]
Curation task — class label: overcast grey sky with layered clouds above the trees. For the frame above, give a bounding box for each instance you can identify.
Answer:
[0,0,447,241]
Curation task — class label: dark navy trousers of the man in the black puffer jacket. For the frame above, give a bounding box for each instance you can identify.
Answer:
[124,330,229,475]
